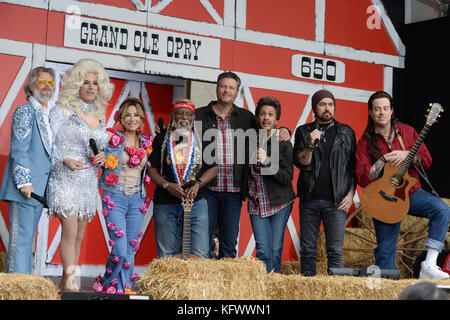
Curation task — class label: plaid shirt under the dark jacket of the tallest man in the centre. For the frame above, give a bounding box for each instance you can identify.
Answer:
[210,111,241,192]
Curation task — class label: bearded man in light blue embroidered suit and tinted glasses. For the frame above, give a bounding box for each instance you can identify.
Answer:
[0,67,55,274]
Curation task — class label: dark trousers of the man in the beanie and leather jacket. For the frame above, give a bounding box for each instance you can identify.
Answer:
[299,200,347,276]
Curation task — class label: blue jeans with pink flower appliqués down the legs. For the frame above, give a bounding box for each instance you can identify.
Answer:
[102,191,145,293]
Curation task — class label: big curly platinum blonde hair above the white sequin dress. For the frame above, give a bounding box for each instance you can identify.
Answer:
[56,59,114,118]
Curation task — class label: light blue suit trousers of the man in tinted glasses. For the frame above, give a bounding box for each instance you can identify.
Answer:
[6,201,44,274]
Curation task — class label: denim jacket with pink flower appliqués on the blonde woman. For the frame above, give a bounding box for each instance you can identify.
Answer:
[99,131,152,198]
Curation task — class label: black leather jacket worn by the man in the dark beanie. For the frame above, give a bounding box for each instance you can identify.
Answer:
[294,120,356,207]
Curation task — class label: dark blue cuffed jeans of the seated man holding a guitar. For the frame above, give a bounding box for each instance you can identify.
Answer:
[373,189,450,269]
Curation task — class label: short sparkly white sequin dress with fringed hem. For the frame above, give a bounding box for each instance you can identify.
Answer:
[47,101,108,221]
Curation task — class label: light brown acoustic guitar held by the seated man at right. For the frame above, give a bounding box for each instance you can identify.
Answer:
[361,103,443,223]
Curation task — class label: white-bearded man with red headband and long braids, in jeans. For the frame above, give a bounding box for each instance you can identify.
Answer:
[150,100,217,258]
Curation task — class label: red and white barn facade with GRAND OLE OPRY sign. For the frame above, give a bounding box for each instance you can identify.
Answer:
[0,0,405,276]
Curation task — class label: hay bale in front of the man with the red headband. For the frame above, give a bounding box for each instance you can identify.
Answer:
[136,258,267,300]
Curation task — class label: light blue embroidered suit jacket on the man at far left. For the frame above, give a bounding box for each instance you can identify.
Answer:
[0,99,52,206]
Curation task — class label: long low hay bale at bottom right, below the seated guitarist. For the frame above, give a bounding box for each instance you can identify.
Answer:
[266,273,450,300]
